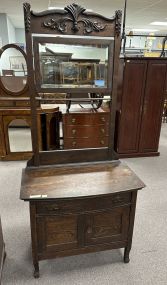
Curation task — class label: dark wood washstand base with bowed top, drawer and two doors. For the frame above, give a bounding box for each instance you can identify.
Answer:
[20,161,144,277]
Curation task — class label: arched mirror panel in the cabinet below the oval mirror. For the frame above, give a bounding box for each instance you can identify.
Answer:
[8,119,32,152]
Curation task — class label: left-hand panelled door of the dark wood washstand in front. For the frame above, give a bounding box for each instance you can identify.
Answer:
[37,215,78,255]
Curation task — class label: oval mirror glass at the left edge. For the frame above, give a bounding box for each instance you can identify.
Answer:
[0,48,27,92]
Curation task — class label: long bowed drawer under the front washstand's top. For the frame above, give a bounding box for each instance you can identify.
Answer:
[36,192,131,215]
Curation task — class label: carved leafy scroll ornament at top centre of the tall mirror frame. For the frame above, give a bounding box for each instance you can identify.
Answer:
[43,3,105,33]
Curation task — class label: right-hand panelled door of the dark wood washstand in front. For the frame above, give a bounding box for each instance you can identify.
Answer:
[85,206,130,244]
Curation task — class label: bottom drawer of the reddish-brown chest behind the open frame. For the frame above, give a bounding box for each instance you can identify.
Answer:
[64,136,108,149]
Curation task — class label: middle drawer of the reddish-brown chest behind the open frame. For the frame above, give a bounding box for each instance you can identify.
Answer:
[63,124,109,138]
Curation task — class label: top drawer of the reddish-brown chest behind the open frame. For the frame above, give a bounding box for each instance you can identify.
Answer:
[63,112,109,125]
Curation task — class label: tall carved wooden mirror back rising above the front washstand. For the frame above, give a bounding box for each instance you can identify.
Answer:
[24,3,121,166]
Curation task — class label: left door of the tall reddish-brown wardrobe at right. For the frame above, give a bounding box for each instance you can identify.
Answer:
[117,60,147,154]
